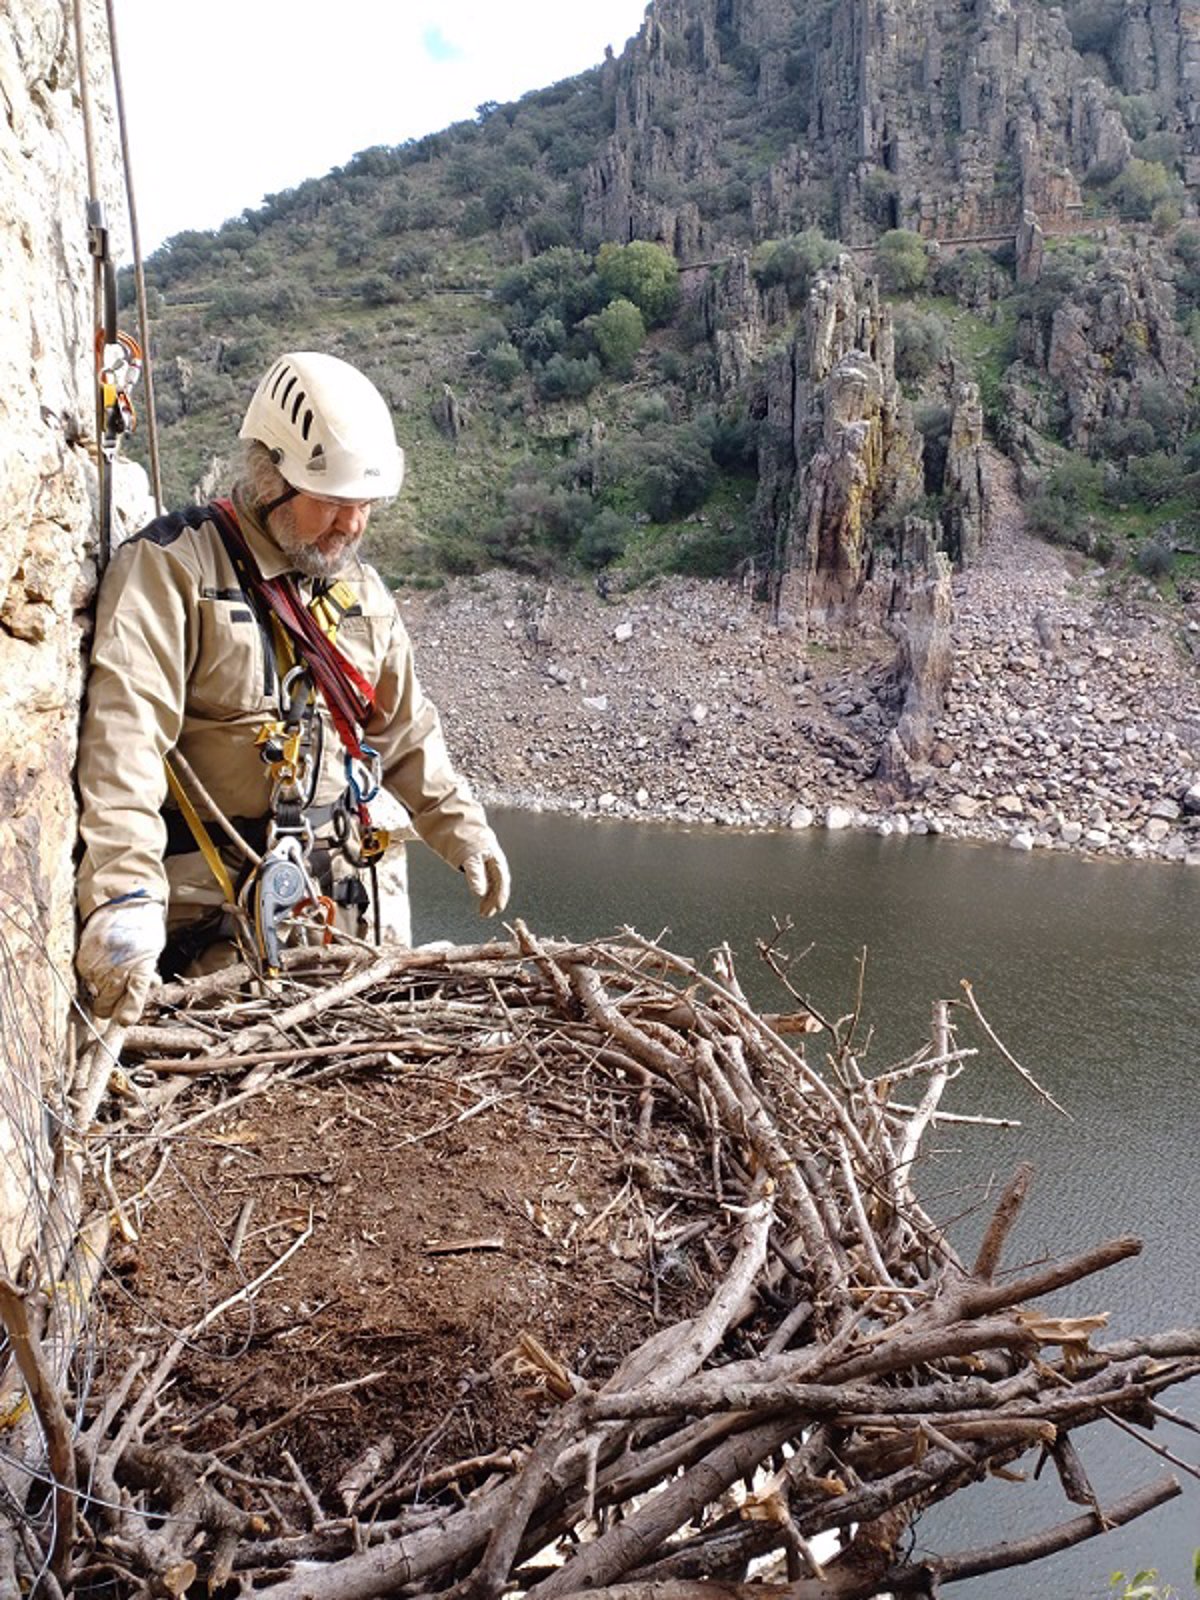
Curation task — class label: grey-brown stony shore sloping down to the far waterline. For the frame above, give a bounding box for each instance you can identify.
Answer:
[400,499,1200,866]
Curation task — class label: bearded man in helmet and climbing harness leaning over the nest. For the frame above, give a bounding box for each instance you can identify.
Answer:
[77,352,509,1024]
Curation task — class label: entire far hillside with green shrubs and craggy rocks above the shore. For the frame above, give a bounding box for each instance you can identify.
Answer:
[124,0,1200,620]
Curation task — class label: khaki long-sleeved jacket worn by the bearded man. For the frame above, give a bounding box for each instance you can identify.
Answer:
[78,507,491,920]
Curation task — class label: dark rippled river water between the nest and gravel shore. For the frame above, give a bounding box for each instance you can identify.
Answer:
[410,811,1200,1600]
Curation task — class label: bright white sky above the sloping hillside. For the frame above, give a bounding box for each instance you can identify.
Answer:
[115,0,646,254]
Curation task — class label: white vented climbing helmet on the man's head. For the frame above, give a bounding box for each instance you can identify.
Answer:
[238,350,405,501]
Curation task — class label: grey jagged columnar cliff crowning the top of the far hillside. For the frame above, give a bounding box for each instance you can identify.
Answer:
[582,0,1200,259]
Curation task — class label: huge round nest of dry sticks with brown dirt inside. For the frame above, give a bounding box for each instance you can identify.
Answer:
[0,923,1200,1600]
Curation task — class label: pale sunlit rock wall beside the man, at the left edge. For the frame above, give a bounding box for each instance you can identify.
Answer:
[0,0,115,1266]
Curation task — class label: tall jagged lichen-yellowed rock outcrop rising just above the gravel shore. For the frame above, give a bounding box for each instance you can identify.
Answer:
[757,256,923,614]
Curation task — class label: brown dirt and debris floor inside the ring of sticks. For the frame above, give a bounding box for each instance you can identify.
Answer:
[104,1067,726,1510]
